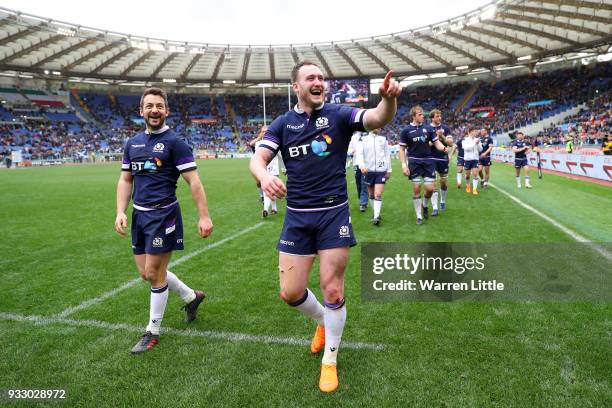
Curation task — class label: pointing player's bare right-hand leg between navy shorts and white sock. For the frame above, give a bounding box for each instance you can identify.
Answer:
[319,247,349,303]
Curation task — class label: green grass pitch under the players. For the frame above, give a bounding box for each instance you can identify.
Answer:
[0,159,612,407]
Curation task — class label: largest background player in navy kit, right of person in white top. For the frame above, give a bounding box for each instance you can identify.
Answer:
[400,105,448,225]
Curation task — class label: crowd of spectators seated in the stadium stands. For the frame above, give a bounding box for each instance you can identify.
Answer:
[0,62,612,160]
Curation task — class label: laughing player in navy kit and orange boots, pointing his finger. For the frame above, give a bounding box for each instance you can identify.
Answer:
[250,61,401,392]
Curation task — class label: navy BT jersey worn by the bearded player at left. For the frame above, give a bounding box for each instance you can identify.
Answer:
[121,126,197,210]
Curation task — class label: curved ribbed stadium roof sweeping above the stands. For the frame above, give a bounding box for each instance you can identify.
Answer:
[0,0,612,87]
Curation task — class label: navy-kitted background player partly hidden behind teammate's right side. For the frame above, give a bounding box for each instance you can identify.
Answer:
[429,109,453,217]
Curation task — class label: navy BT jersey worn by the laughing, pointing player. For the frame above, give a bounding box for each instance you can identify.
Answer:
[258,103,365,210]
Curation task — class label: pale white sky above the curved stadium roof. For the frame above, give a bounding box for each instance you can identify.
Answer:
[0,0,490,44]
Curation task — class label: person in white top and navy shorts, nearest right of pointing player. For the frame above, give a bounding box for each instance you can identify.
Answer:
[356,130,392,225]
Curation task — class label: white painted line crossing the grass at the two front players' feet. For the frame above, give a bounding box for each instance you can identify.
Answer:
[0,312,385,350]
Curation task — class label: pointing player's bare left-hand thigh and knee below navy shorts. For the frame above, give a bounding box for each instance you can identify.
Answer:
[278,252,315,302]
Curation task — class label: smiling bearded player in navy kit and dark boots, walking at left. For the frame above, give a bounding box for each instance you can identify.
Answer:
[115,88,213,354]
